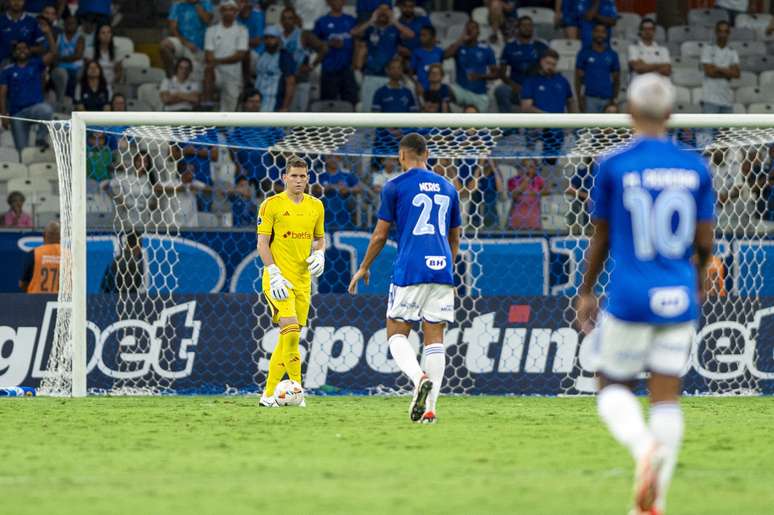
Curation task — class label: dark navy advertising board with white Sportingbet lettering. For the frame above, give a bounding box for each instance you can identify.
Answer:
[0,293,774,395]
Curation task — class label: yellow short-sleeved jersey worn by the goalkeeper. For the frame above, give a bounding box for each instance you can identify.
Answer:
[258,191,325,290]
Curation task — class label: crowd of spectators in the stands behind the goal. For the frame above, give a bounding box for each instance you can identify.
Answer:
[0,0,774,231]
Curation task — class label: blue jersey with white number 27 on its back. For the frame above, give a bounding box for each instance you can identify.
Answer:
[379,168,462,286]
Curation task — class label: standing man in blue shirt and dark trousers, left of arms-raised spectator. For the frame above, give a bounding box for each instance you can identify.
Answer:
[314,0,358,106]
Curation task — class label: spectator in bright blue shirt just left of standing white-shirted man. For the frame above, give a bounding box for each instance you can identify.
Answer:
[160,0,213,77]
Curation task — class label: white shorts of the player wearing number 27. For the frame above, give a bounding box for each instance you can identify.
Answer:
[387,284,454,323]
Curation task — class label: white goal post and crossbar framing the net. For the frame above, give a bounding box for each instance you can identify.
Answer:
[57,112,774,397]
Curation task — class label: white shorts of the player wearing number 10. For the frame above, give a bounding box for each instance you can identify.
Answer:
[596,313,695,381]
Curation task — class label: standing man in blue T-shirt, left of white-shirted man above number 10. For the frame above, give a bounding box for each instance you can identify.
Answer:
[575,24,621,113]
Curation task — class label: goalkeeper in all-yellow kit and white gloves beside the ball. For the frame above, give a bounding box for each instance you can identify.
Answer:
[258,158,325,407]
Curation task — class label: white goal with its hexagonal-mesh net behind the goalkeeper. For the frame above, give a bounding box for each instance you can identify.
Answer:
[41,113,774,395]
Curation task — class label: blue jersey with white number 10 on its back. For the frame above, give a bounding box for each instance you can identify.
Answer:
[592,137,715,324]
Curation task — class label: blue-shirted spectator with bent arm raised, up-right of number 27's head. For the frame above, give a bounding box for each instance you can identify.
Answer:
[443,20,499,112]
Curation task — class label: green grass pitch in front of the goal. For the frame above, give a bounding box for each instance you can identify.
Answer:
[0,397,774,515]
